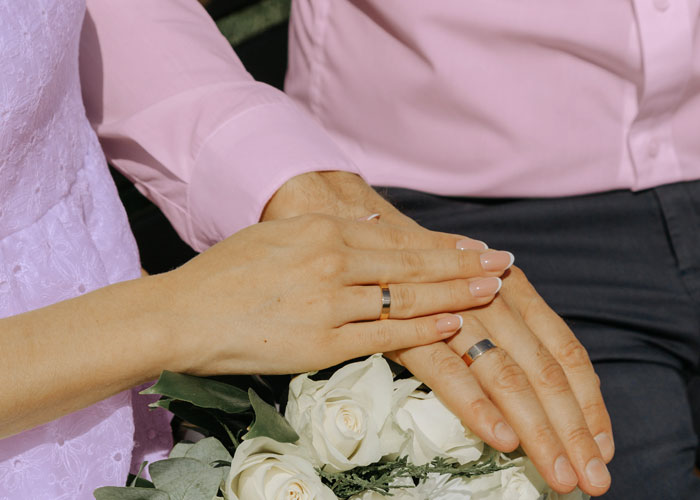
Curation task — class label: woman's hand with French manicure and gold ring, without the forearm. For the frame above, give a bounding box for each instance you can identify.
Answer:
[166,215,512,375]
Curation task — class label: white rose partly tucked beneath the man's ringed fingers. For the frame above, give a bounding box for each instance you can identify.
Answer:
[395,380,484,465]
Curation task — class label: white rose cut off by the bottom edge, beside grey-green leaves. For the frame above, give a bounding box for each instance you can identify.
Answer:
[224,437,337,500]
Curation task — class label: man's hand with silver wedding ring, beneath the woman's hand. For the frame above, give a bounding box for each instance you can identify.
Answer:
[263,172,614,495]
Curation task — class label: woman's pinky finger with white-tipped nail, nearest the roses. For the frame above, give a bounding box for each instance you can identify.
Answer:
[334,314,463,359]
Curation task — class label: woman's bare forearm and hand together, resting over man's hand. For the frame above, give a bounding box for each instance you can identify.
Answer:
[0,215,510,438]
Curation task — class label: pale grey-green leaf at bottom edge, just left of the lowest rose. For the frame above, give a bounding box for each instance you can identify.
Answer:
[148,458,223,500]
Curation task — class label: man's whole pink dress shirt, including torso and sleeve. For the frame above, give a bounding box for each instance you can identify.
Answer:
[90,0,700,244]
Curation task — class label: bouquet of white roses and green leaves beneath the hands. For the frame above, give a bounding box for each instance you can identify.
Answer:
[95,355,588,500]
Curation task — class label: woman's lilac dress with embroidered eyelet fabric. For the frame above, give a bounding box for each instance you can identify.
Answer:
[0,0,171,500]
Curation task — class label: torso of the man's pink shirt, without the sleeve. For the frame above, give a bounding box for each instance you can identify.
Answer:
[286,0,700,197]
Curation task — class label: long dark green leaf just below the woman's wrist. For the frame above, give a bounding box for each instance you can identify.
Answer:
[141,370,250,414]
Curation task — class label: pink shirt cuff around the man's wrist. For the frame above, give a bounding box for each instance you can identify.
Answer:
[188,103,360,252]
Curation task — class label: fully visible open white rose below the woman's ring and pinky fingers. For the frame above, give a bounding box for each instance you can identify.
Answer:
[285,355,400,472]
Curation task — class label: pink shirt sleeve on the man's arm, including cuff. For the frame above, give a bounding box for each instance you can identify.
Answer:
[80,0,359,251]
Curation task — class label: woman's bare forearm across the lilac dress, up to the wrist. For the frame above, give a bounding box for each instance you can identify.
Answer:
[0,276,177,438]
